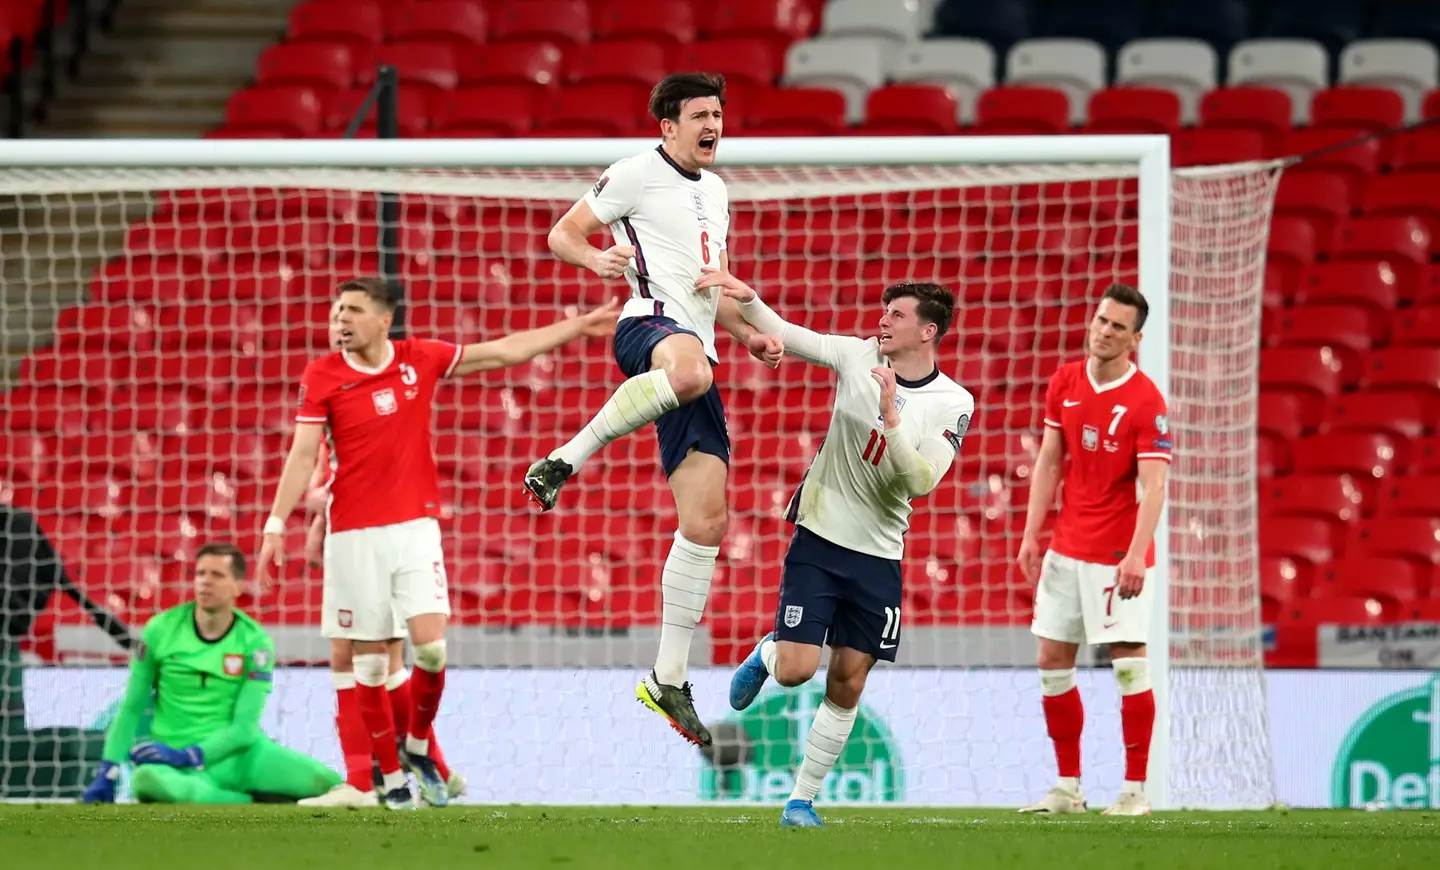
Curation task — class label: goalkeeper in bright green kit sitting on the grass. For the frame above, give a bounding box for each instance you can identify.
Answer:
[84,543,340,804]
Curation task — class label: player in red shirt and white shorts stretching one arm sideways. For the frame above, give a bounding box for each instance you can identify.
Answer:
[258,278,619,810]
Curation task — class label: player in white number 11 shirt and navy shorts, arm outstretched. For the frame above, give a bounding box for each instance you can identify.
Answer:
[700,272,975,827]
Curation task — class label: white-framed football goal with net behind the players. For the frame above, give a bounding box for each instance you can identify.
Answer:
[0,137,1279,807]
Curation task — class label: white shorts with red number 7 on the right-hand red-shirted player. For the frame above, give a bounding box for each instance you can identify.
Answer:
[1030,550,1155,645]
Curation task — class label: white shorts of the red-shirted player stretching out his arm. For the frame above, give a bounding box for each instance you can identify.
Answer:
[321,519,451,641]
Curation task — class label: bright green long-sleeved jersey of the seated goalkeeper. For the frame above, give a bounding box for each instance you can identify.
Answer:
[104,602,275,763]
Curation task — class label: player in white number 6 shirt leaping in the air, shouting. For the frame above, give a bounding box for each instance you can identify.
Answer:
[524,73,783,746]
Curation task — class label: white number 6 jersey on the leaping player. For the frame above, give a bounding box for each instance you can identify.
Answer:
[585,147,730,360]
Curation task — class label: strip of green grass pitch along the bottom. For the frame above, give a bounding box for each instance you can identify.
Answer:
[0,804,1440,870]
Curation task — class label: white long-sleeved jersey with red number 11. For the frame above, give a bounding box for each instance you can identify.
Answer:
[740,300,975,559]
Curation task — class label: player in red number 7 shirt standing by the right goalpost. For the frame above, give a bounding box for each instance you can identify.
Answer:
[1020,284,1171,815]
